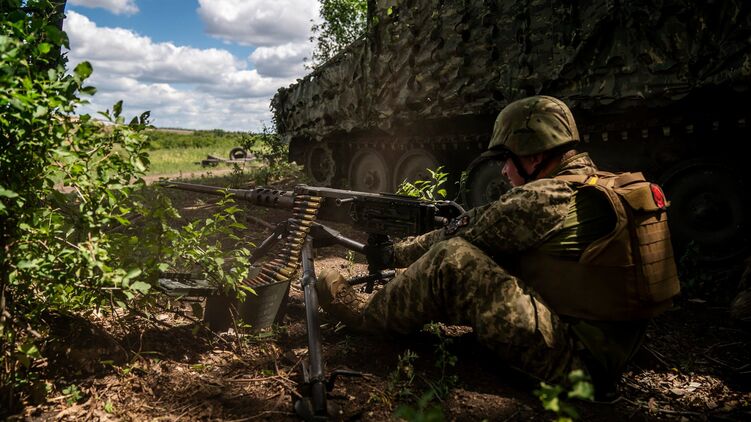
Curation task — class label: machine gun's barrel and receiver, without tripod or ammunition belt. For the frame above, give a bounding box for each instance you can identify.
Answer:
[162,181,464,237]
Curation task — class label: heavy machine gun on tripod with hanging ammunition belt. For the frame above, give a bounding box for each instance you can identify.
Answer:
[162,181,465,420]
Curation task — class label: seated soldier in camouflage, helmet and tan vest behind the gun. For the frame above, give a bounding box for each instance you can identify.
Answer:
[316,96,679,399]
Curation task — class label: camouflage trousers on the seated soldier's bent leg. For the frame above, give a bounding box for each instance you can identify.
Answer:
[362,237,581,380]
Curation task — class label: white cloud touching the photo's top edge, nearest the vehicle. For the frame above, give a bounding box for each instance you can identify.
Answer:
[198,0,320,47]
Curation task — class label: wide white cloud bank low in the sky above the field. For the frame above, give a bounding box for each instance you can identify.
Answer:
[64,11,304,130]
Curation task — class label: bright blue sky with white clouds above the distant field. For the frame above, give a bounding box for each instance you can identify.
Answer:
[65,0,319,131]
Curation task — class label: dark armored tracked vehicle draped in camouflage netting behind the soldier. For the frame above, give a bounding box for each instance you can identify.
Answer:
[272,0,751,261]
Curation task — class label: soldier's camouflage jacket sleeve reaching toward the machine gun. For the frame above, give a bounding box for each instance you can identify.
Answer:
[394,179,574,267]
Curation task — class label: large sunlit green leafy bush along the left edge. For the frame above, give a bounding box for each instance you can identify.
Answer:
[0,0,159,417]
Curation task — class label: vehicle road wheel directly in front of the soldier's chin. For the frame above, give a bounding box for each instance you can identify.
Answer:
[461,158,511,208]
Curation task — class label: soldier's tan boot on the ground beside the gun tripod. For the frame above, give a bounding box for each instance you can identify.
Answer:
[315,269,367,330]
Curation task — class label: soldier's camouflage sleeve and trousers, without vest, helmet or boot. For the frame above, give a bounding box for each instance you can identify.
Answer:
[362,154,596,379]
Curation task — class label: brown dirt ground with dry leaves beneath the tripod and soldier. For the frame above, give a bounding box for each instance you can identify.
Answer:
[14,180,751,421]
